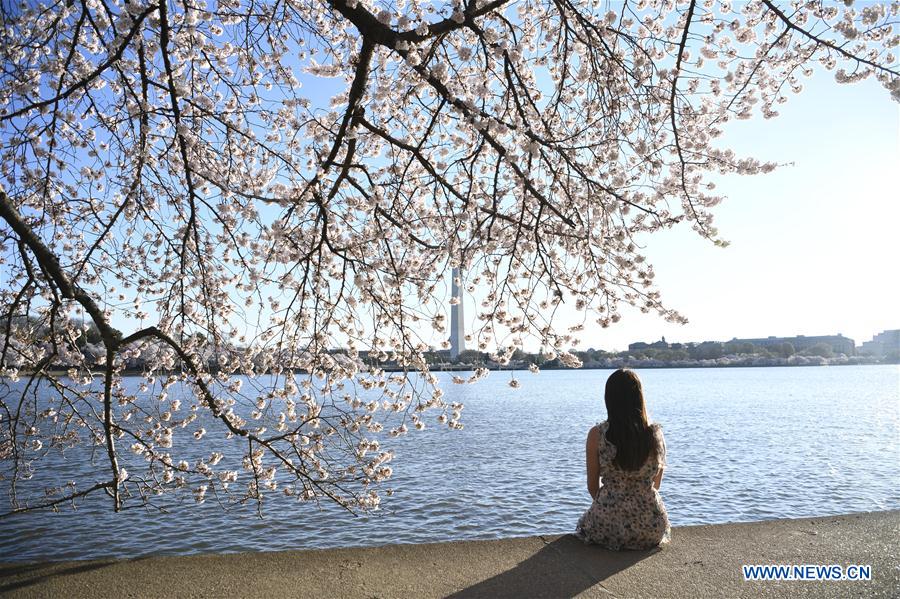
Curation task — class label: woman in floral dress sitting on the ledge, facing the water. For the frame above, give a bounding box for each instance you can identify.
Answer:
[575,369,670,550]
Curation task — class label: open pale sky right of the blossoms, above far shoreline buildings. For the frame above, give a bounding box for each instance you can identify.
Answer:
[581,72,900,349]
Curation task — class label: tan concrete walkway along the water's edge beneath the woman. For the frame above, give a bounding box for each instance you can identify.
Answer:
[0,511,900,598]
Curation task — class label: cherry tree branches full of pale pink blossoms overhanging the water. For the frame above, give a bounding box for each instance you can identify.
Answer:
[0,0,900,515]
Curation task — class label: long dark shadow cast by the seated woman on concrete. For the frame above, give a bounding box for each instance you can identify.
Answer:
[449,535,660,599]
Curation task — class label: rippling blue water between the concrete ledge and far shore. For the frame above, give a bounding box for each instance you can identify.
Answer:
[0,366,900,560]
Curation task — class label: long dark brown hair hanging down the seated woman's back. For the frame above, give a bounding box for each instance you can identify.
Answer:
[604,368,656,470]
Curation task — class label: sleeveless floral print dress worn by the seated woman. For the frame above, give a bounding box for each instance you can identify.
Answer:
[575,422,670,550]
